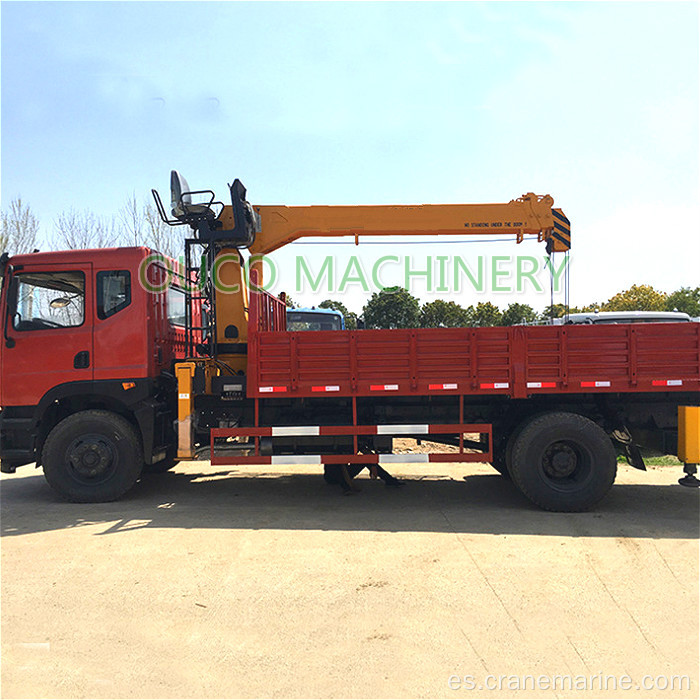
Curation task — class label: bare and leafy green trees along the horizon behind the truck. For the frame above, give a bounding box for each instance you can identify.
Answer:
[5,193,700,329]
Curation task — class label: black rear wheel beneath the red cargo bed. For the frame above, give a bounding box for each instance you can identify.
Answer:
[510,412,617,513]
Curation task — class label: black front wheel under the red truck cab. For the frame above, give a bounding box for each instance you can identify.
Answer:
[42,410,143,503]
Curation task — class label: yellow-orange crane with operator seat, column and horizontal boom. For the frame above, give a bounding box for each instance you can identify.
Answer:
[153,171,571,371]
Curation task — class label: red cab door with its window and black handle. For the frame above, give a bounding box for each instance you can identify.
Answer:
[0,263,93,406]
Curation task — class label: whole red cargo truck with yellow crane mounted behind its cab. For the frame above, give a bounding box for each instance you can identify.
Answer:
[0,173,700,511]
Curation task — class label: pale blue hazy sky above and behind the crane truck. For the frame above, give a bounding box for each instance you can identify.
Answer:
[0,0,700,311]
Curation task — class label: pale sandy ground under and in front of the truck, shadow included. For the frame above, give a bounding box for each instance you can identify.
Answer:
[0,462,700,698]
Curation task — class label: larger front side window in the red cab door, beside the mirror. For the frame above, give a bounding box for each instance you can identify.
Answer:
[12,271,85,331]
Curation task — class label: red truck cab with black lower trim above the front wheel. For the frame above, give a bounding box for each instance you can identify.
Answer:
[0,247,185,495]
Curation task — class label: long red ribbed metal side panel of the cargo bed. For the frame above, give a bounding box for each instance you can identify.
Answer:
[248,296,700,398]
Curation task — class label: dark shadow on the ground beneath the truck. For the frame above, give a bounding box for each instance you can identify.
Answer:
[0,467,700,539]
